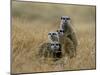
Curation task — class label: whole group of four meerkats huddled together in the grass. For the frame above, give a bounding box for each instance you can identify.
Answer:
[39,16,77,58]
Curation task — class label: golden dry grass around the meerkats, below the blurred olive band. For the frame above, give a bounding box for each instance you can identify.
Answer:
[12,1,96,73]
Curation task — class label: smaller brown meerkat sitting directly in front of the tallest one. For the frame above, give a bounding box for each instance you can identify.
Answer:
[57,29,76,58]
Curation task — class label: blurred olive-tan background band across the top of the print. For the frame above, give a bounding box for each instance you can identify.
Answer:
[12,1,95,23]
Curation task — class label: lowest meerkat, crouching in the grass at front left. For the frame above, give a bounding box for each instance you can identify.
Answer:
[38,42,62,59]
